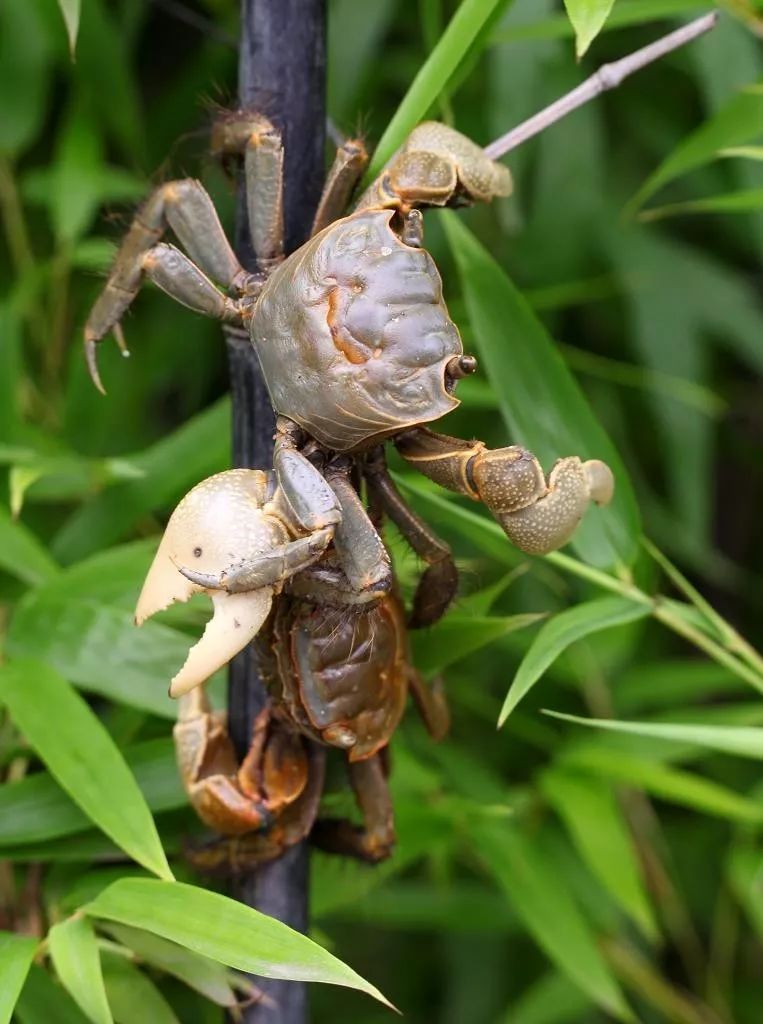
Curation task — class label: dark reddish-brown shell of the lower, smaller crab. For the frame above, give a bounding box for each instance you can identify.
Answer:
[273,594,410,761]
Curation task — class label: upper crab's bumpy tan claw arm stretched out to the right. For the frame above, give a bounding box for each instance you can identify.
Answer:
[395,427,614,555]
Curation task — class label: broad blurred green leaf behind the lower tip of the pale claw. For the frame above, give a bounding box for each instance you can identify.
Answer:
[7,590,193,720]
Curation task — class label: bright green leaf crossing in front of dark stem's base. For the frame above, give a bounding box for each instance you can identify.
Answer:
[83,879,390,1006]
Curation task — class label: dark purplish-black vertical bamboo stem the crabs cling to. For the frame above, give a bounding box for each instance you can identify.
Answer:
[227,0,326,1024]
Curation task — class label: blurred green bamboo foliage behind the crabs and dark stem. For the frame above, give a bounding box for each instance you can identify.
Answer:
[0,0,763,1024]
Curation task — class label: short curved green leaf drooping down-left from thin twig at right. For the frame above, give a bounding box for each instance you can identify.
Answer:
[498,597,650,726]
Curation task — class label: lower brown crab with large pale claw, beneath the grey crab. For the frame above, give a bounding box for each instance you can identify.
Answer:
[136,462,449,872]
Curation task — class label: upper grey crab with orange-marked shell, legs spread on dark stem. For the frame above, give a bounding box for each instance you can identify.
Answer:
[85,116,613,626]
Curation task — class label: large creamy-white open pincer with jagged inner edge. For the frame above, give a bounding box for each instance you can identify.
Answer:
[135,469,283,697]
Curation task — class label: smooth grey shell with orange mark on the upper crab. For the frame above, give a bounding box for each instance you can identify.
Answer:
[251,210,463,452]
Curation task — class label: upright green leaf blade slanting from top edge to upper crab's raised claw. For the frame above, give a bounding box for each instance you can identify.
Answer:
[366,0,502,182]
